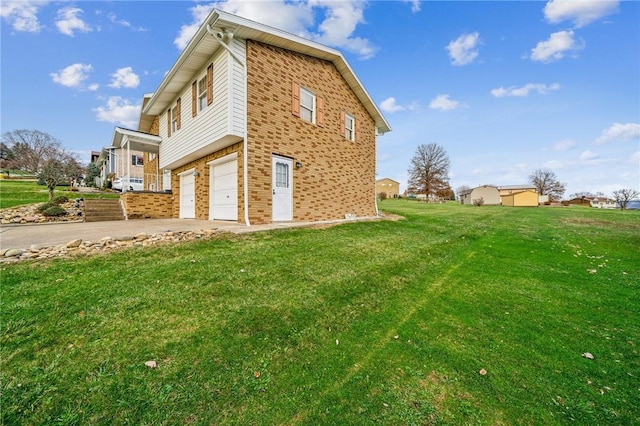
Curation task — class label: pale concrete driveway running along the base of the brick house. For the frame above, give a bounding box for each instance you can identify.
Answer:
[0,218,378,249]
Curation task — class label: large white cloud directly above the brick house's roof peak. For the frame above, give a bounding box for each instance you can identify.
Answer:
[173,0,377,59]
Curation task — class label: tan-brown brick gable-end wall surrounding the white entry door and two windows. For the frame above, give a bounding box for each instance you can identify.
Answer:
[247,40,375,224]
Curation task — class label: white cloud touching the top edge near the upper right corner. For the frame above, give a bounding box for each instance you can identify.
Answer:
[544,0,619,28]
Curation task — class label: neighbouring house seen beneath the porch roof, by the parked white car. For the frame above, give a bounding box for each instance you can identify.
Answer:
[96,143,144,192]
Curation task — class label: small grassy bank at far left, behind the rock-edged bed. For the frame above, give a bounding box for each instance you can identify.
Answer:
[0,179,119,209]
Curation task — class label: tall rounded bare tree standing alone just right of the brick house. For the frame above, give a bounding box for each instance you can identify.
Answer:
[408,143,451,198]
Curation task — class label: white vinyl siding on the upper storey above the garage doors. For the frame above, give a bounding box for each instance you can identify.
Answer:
[159,39,246,169]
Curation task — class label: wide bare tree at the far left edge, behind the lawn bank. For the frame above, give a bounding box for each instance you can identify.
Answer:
[2,129,62,174]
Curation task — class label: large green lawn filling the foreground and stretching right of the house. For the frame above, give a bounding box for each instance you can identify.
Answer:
[0,200,640,425]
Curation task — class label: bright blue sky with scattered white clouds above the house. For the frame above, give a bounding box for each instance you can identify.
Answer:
[0,0,640,197]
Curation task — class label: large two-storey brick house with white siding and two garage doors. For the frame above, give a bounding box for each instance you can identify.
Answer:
[112,10,391,225]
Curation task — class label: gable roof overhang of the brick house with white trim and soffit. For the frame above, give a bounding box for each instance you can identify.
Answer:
[142,9,391,134]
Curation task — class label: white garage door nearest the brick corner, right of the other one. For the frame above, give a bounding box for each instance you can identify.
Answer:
[209,156,238,220]
